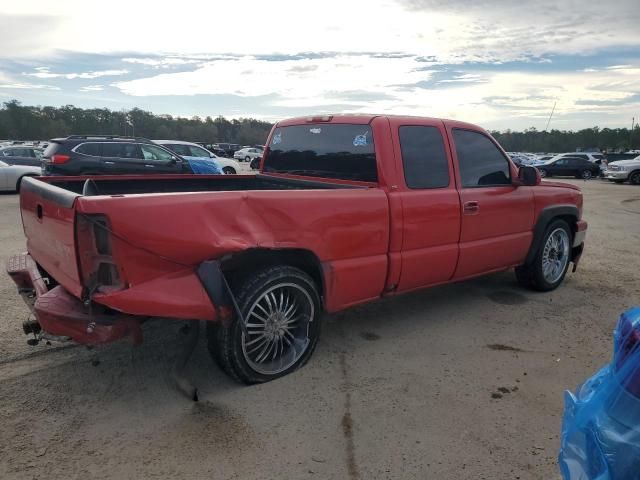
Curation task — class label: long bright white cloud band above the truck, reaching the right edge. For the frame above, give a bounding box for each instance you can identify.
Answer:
[113,55,640,128]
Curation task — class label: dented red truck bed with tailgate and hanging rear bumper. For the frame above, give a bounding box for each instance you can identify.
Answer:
[7,174,389,345]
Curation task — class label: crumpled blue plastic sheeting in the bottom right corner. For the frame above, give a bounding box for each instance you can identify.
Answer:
[558,307,640,480]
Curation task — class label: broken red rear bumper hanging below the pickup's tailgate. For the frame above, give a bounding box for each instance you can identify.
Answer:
[7,253,144,345]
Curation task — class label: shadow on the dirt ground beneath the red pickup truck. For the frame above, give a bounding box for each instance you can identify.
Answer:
[0,272,536,403]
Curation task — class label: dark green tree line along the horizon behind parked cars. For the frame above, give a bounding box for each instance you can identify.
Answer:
[0,100,640,152]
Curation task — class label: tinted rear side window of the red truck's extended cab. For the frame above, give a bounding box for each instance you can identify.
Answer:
[399,126,449,188]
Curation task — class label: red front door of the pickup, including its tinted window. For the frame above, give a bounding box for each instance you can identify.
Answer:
[446,122,534,279]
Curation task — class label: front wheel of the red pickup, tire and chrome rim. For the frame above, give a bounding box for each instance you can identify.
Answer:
[516,220,572,292]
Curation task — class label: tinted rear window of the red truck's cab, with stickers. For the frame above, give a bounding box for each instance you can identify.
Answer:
[264,123,378,182]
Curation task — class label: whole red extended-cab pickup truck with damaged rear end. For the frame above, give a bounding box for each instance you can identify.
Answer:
[8,115,587,383]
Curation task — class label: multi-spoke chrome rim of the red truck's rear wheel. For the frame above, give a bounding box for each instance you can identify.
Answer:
[242,283,315,375]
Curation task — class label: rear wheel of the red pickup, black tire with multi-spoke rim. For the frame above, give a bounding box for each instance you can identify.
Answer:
[207,266,321,384]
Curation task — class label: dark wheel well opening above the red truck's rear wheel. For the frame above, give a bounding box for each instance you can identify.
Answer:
[220,248,324,297]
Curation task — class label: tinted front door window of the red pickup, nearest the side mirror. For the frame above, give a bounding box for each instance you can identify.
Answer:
[453,129,511,187]
